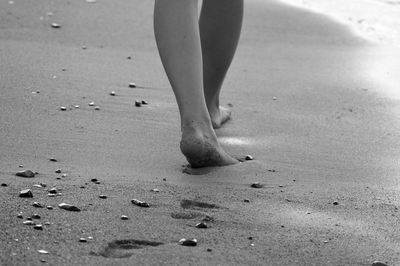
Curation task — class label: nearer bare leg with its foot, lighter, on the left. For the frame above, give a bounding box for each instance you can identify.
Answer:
[154,0,238,167]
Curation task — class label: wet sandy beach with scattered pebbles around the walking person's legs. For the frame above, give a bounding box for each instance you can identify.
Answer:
[0,0,400,265]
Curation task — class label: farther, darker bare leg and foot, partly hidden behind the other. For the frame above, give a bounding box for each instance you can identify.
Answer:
[200,0,243,128]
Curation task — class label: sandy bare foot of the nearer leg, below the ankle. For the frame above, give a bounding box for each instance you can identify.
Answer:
[180,123,239,168]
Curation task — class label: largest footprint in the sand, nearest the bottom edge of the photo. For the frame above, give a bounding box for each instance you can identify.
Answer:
[91,239,164,258]
